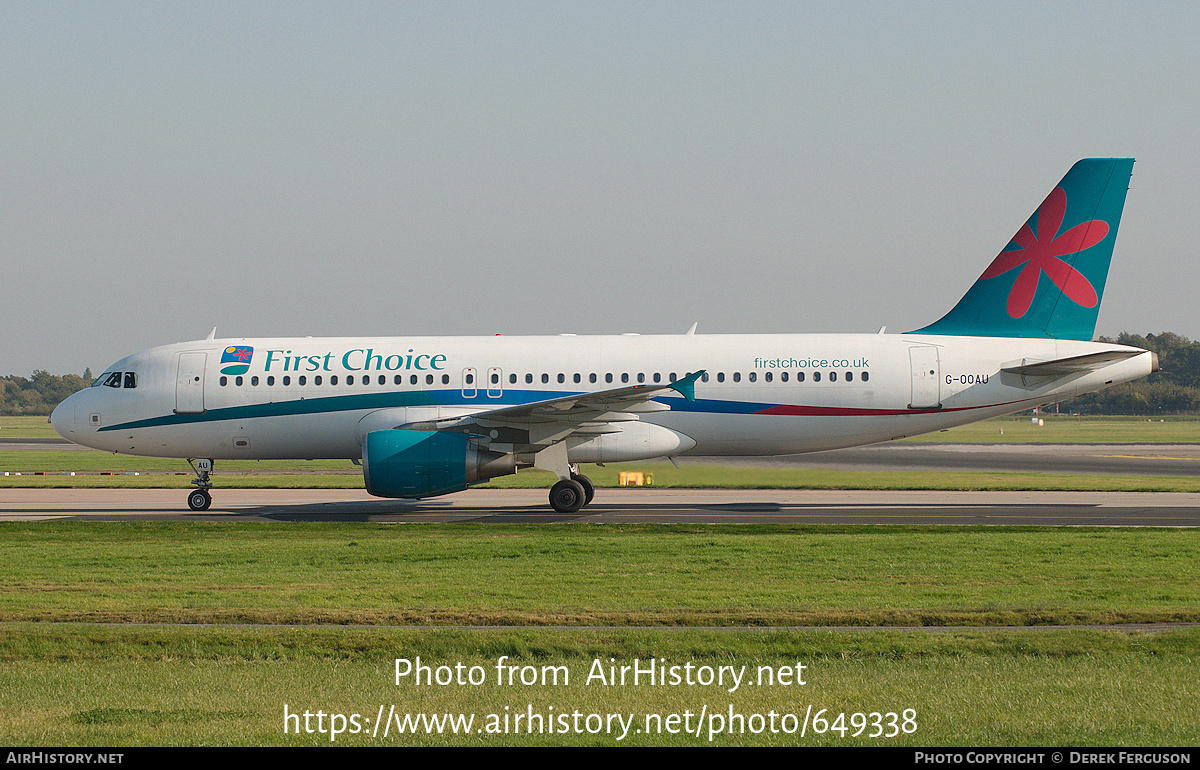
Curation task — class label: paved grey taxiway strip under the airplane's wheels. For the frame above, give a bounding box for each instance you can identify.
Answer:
[0,488,1200,527]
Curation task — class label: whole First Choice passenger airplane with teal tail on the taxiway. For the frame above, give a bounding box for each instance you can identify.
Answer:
[50,158,1159,513]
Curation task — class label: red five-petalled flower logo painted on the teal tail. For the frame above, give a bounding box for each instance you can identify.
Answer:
[979,187,1109,318]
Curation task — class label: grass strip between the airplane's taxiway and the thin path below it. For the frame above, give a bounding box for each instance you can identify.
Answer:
[0,522,1200,626]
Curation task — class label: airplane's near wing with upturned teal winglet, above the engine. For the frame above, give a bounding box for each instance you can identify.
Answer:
[402,371,704,450]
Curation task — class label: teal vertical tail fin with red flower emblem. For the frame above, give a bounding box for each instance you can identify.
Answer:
[908,158,1133,339]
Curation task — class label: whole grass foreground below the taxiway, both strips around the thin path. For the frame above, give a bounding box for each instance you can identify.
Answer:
[0,523,1200,745]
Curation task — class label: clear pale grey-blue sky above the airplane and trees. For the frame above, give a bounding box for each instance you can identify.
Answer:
[0,0,1200,377]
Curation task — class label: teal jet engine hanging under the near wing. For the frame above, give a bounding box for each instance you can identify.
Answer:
[362,431,516,498]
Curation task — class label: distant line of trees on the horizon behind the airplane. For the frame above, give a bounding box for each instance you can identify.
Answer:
[7,331,1200,416]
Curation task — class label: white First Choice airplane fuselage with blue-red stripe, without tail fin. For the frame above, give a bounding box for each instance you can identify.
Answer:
[52,335,1153,463]
